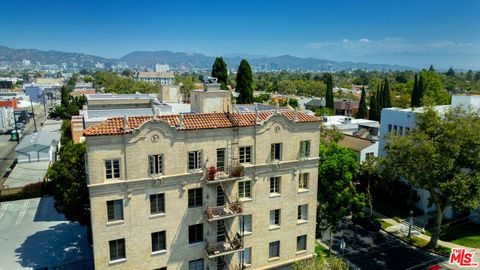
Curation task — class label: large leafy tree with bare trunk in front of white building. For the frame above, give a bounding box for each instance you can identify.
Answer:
[381,107,480,248]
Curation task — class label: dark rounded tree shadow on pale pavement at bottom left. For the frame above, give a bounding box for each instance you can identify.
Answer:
[15,222,93,269]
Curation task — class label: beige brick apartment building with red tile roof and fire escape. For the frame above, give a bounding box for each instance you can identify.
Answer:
[84,106,320,270]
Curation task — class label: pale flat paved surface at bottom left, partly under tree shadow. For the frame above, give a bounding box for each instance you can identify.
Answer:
[0,197,93,270]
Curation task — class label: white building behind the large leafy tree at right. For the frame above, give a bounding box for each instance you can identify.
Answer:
[379,95,480,218]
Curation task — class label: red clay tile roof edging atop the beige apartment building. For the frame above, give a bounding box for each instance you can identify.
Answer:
[83,111,321,136]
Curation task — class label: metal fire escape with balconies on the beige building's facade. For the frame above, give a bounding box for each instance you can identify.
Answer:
[203,106,244,270]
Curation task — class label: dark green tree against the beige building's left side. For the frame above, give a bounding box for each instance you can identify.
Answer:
[48,143,90,226]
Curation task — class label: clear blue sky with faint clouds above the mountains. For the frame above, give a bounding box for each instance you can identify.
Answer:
[0,0,480,69]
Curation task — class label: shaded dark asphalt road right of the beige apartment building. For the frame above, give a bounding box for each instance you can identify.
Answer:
[322,221,447,270]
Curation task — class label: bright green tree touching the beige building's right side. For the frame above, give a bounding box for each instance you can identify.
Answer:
[317,142,365,252]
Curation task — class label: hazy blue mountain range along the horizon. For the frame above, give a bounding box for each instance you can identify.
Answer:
[0,46,413,71]
